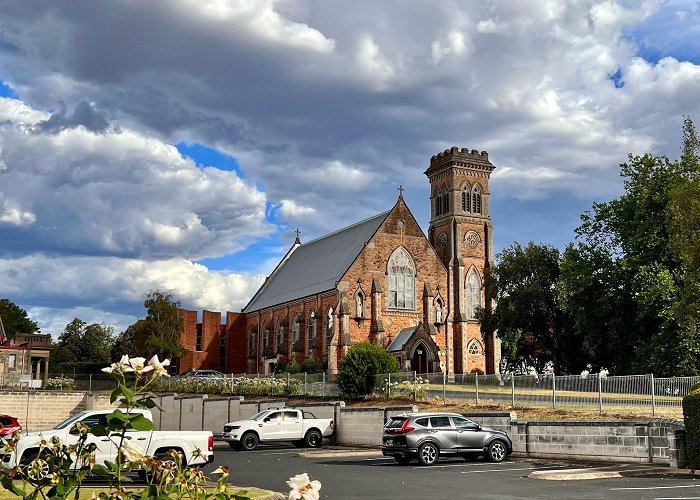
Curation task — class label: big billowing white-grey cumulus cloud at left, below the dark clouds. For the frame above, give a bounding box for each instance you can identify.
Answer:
[0,99,271,258]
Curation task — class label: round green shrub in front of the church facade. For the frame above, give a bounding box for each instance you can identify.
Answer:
[338,342,399,398]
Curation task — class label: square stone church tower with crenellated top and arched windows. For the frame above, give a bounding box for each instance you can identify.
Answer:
[425,147,501,373]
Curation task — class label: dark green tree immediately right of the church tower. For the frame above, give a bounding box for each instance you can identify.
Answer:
[477,242,580,373]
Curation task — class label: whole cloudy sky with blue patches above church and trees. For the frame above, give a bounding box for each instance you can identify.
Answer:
[0,0,700,334]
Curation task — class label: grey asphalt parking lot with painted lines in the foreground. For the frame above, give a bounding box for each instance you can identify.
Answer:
[209,445,700,500]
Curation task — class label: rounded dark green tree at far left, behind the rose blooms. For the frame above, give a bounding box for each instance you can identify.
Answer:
[49,318,114,373]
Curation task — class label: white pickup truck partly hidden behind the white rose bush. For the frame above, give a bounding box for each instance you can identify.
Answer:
[1,408,214,479]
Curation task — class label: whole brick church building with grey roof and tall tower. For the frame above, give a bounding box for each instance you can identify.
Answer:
[237,147,500,374]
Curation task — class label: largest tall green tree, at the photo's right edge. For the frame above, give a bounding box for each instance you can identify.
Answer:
[561,119,700,376]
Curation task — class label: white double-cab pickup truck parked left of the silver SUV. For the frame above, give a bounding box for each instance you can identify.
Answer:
[221,408,333,451]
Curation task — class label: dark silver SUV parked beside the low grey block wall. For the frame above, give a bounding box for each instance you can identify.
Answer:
[382,413,513,465]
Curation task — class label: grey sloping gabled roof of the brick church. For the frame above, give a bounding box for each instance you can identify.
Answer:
[243,210,391,313]
